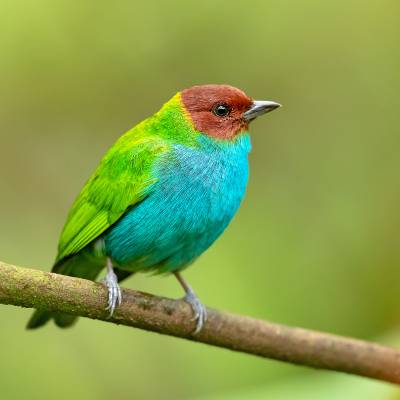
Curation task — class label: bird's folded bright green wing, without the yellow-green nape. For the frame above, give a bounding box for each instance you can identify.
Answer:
[56,125,166,263]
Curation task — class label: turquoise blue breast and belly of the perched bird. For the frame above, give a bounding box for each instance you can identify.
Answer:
[104,134,250,272]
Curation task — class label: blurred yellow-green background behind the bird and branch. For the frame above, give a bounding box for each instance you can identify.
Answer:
[0,0,400,400]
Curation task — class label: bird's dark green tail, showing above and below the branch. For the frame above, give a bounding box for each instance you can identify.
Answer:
[26,250,105,329]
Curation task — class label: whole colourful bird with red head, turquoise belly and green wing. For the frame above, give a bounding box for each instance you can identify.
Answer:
[27,84,281,334]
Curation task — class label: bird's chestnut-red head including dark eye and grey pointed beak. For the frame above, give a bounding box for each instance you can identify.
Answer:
[181,85,280,139]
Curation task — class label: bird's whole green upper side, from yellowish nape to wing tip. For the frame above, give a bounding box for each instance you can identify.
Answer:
[56,93,198,264]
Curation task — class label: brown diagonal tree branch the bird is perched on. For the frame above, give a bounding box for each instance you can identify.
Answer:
[0,262,400,383]
